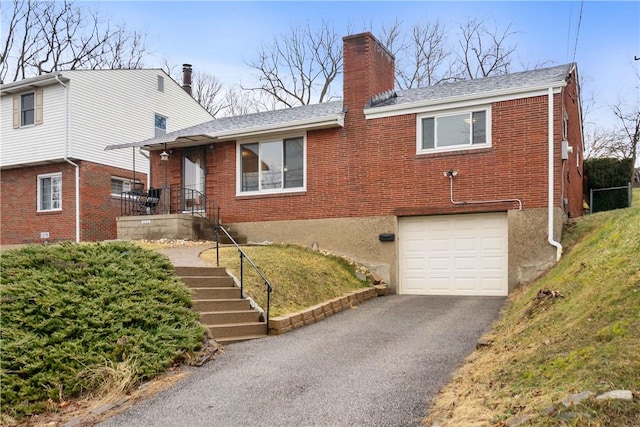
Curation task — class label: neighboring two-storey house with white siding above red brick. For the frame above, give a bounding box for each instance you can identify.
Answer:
[0,67,212,245]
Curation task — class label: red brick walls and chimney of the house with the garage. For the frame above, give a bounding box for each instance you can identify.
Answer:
[144,33,581,227]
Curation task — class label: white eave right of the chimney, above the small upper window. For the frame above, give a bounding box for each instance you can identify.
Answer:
[364,80,567,119]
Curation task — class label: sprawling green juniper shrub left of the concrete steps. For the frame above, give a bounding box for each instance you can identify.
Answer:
[0,242,205,416]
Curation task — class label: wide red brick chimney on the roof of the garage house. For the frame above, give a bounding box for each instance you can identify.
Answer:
[342,33,395,114]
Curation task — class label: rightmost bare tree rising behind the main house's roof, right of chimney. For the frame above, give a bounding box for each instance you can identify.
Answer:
[457,19,516,79]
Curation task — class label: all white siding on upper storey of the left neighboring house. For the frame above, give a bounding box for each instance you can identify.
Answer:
[0,70,213,173]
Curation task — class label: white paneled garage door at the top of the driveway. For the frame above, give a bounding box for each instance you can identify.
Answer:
[399,213,508,295]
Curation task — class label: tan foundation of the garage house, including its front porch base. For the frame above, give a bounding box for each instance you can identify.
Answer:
[117,208,563,293]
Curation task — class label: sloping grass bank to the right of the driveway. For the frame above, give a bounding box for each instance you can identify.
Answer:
[424,189,640,426]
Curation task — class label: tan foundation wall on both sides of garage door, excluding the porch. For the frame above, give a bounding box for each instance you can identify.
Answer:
[231,208,563,293]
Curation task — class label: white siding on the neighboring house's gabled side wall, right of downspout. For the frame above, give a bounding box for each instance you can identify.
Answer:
[65,70,212,172]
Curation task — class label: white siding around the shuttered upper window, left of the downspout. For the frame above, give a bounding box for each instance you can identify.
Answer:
[0,84,65,167]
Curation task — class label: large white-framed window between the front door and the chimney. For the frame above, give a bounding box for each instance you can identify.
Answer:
[238,137,305,193]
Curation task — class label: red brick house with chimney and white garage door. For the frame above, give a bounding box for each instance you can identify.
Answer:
[109,33,583,295]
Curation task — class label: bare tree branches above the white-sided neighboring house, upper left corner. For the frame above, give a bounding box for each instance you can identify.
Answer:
[0,0,146,83]
